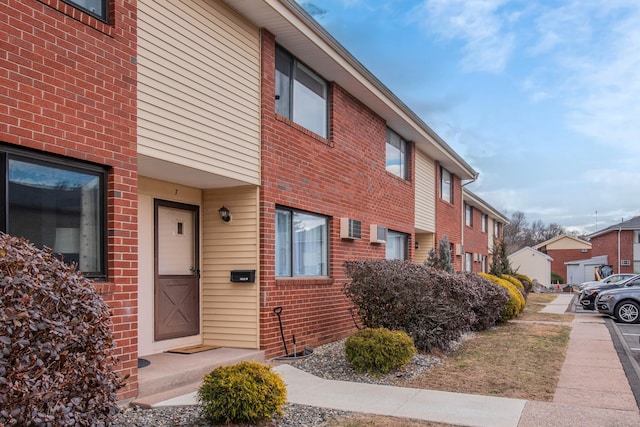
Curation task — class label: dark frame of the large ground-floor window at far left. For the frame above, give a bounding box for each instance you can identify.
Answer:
[0,144,108,280]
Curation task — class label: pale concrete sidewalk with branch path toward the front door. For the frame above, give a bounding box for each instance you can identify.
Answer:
[148,294,640,427]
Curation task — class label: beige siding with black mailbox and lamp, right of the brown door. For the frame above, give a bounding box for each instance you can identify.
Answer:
[202,186,260,348]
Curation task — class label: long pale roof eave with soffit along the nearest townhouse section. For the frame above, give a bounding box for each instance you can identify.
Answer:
[224,0,478,180]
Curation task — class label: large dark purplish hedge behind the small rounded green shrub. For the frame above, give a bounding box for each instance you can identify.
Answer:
[343,260,508,351]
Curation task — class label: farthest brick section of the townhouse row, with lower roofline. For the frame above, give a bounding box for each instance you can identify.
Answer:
[460,187,509,273]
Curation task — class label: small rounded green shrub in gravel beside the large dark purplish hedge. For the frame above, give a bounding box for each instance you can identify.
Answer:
[345,328,416,375]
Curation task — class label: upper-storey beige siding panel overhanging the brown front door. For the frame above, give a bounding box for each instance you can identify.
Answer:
[137,0,260,185]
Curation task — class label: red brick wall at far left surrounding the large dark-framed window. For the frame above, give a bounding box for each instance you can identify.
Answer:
[0,0,138,399]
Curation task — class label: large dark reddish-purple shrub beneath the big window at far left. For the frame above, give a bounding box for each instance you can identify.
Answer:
[0,233,120,426]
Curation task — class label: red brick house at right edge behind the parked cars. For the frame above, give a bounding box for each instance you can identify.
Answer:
[588,216,640,273]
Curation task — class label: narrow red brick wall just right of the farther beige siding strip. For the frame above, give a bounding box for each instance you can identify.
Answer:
[435,165,466,271]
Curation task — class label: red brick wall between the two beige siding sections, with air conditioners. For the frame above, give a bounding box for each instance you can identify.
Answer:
[260,31,414,358]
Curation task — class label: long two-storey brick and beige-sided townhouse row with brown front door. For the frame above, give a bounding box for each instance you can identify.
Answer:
[0,0,507,399]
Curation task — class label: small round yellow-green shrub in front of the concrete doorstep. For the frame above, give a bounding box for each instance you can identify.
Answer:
[197,362,287,424]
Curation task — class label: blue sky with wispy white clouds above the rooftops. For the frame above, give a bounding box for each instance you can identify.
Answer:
[297,0,640,233]
